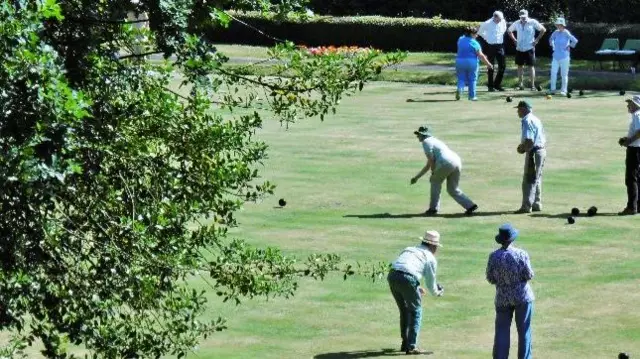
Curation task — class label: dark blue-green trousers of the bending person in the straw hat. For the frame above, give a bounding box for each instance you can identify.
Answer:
[387,270,422,350]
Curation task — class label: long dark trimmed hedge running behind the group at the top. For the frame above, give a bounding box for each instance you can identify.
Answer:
[208,14,640,59]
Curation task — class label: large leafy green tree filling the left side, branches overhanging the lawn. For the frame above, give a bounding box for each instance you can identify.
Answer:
[0,0,402,358]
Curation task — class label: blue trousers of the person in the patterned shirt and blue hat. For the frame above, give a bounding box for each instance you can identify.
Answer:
[493,302,533,359]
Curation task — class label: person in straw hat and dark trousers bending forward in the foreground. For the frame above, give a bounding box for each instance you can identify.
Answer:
[387,231,444,354]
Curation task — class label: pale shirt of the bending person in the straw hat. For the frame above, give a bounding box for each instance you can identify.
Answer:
[391,244,438,295]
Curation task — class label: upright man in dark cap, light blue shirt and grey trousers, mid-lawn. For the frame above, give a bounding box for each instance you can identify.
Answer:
[515,100,547,214]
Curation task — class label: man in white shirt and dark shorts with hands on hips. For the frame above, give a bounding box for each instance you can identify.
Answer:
[507,10,547,91]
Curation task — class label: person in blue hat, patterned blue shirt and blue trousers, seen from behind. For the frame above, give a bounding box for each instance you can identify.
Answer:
[487,223,535,359]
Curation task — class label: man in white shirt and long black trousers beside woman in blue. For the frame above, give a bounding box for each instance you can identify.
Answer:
[478,11,507,92]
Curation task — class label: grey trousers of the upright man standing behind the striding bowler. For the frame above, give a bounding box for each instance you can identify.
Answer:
[520,149,547,209]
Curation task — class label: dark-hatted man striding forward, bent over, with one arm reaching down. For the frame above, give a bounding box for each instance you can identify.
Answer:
[411,126,478,216]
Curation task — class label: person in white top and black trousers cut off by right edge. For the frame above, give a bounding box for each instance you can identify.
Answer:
[618,95,640,216]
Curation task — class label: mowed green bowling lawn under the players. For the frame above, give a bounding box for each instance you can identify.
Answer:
[190,82,640,359]
